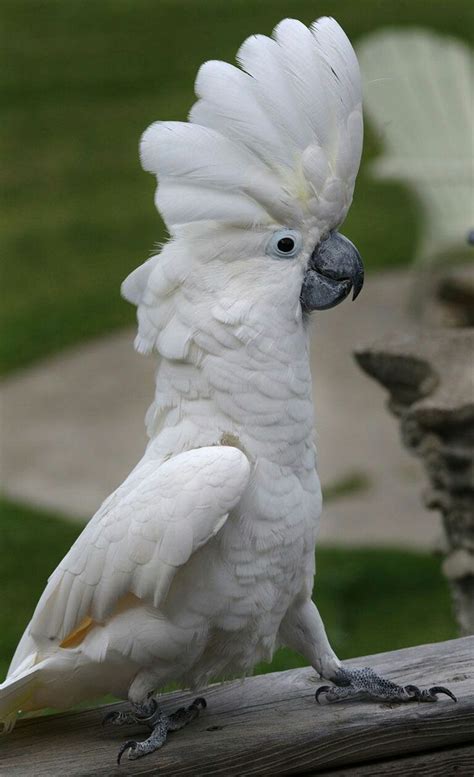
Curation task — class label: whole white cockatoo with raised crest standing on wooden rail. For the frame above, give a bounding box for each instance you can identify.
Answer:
[0,18,454,758]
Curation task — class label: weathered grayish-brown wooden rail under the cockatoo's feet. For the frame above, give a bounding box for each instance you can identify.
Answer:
[0,637,474,777]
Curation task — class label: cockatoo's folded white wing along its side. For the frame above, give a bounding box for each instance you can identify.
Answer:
[29,446,250,640]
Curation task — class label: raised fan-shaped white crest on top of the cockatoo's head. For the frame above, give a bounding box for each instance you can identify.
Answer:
[139,18,362,233]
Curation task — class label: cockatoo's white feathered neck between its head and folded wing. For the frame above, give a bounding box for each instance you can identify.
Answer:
[147,314,314,469]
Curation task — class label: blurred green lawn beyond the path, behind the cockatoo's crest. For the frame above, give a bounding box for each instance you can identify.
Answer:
[0,0,471,373]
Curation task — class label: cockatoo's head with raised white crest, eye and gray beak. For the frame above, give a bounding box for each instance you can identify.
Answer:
[123,18,364,359]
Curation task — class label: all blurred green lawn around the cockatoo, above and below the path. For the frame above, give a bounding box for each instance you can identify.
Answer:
[0,0,473,688]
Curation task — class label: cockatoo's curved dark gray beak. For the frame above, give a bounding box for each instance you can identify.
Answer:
[300,232,364,313]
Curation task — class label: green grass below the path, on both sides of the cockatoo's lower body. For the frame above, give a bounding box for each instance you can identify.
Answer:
[0,501,456,678]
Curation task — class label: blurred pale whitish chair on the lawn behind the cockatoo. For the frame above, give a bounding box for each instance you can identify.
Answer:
[357,29,474,264]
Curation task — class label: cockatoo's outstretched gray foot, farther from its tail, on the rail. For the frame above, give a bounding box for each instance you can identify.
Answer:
[315,667,457,703]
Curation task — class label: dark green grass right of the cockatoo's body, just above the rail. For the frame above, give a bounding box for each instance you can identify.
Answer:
[257,548,458,672]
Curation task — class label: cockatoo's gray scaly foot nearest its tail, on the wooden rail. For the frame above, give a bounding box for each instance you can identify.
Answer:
[115,697,207,764]
